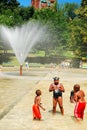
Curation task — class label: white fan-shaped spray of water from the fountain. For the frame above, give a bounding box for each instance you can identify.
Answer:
[0,22,46,65]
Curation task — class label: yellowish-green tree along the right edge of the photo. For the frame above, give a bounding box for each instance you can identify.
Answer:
[71,0,87,57]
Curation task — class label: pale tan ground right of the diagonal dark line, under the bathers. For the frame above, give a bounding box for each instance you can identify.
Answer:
[0,70,87,130]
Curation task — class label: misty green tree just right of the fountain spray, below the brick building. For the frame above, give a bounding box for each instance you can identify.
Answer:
[33,8,67,55]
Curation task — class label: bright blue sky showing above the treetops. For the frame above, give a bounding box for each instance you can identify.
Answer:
[17,0,81,7]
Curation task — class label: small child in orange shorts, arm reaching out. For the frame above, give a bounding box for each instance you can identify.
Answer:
[32,89,45,120]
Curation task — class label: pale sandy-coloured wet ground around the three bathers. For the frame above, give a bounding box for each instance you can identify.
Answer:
[0,68,87,130]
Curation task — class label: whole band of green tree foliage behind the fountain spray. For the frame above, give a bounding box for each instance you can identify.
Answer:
[0,0,87,62]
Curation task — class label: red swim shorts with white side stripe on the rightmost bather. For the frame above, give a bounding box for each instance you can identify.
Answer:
[74,102,86,119]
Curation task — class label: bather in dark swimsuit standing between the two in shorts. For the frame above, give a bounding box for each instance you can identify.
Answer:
[49,77,65,115]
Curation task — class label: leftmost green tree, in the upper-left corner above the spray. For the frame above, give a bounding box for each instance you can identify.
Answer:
[0,0,22,26]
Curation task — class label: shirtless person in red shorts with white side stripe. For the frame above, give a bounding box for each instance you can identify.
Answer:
[74,84,86,121]
